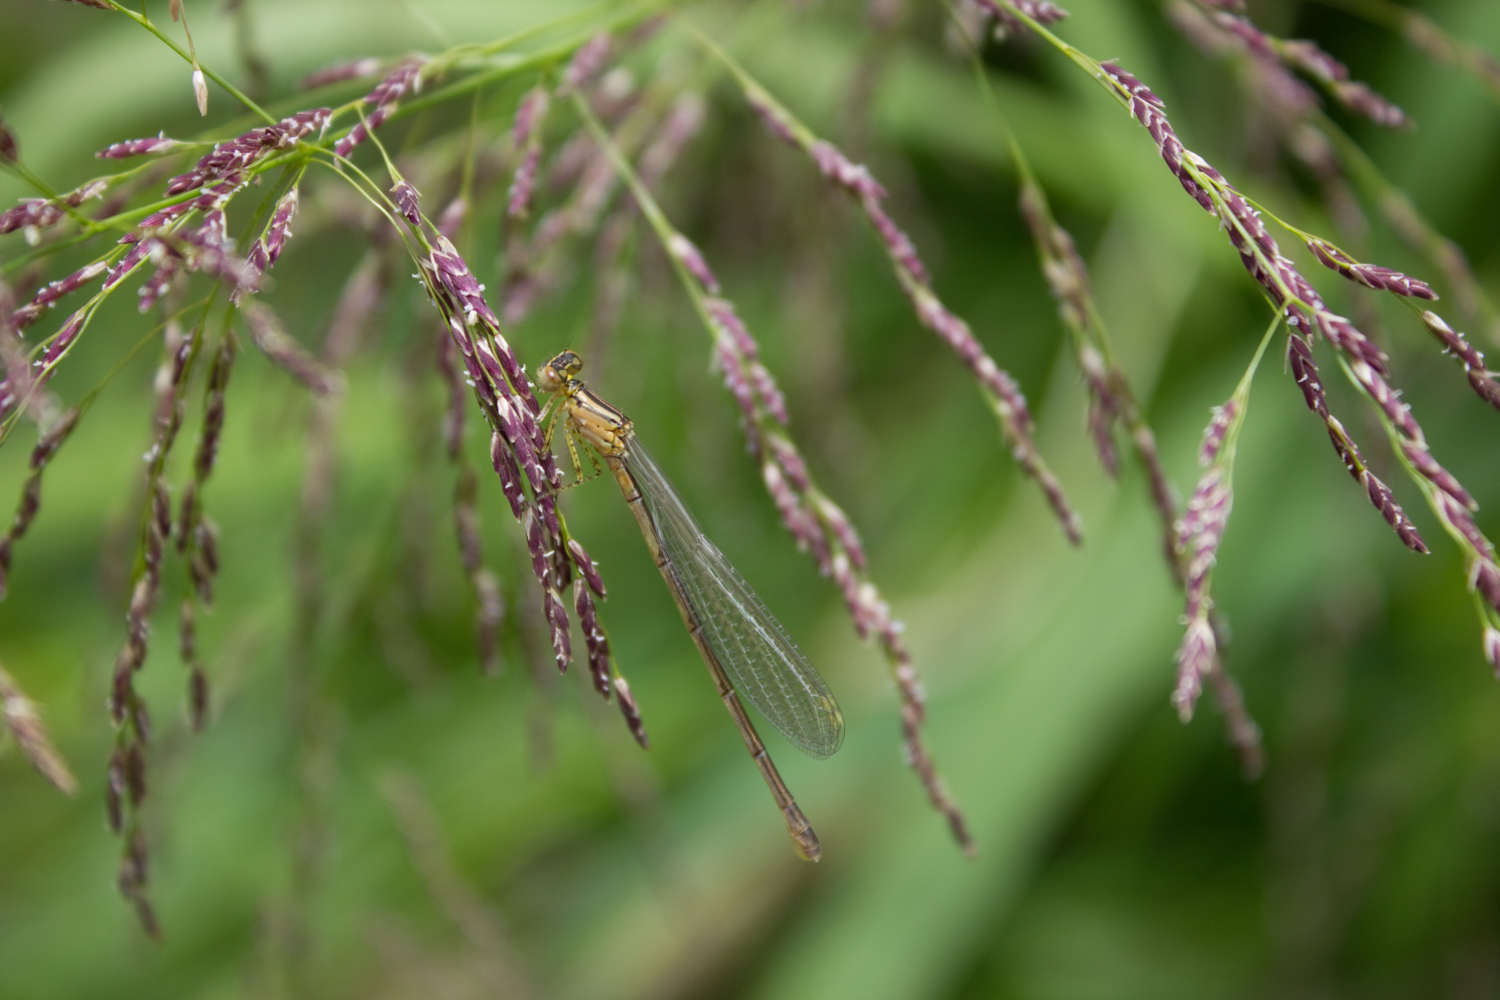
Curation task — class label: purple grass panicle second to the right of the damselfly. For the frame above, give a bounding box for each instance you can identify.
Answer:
[695,29,1083,544]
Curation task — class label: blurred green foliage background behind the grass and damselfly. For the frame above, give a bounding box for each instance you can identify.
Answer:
[0,0,1500,1000]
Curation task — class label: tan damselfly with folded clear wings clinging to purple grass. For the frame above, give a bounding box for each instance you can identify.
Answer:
[537,351,843,861]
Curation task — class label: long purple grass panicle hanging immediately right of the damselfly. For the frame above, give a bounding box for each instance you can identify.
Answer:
[573,96,974,853]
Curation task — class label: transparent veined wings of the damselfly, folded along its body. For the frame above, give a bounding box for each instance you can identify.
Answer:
[626,439,843,760]
